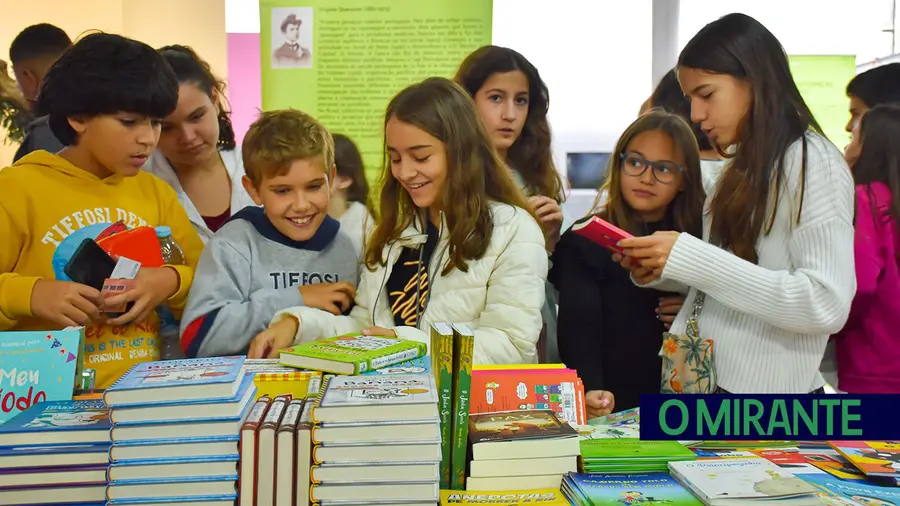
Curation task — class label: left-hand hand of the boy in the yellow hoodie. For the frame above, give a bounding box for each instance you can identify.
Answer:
[31,279,103,327]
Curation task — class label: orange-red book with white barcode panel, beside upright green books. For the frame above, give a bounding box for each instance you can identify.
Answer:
[469,369,587,425]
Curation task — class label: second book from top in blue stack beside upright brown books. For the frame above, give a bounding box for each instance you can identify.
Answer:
[109,374,256,426]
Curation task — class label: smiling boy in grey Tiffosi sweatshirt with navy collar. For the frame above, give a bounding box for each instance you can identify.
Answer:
[181,109,359,357]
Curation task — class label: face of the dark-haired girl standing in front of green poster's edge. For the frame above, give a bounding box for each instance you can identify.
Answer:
[474,70,529,153]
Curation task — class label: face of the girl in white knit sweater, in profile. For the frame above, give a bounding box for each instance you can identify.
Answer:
[678,67,753,148]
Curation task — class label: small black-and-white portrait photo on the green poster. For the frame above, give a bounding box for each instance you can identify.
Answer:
[272,7,313,69]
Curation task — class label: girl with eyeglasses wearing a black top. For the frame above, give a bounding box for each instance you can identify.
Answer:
[549,109,705,417]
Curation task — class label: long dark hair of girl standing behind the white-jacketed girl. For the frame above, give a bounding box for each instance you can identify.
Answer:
[454,46,565,203]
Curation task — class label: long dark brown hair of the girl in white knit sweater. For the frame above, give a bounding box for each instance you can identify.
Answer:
[678,14,822,263]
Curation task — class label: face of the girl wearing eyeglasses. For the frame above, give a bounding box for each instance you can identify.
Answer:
[620,130,685,222]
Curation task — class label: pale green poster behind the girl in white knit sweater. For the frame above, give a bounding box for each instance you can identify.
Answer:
[788,55,856,150]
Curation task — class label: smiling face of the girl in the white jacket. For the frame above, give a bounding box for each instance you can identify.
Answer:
[384,117,447,210]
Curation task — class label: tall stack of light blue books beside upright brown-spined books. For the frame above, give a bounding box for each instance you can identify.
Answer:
[104,357,256,506]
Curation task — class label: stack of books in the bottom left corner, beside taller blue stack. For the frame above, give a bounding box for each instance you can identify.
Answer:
[0,401,110,505]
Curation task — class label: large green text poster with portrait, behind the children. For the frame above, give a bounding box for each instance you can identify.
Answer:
[259,0,493,180]
